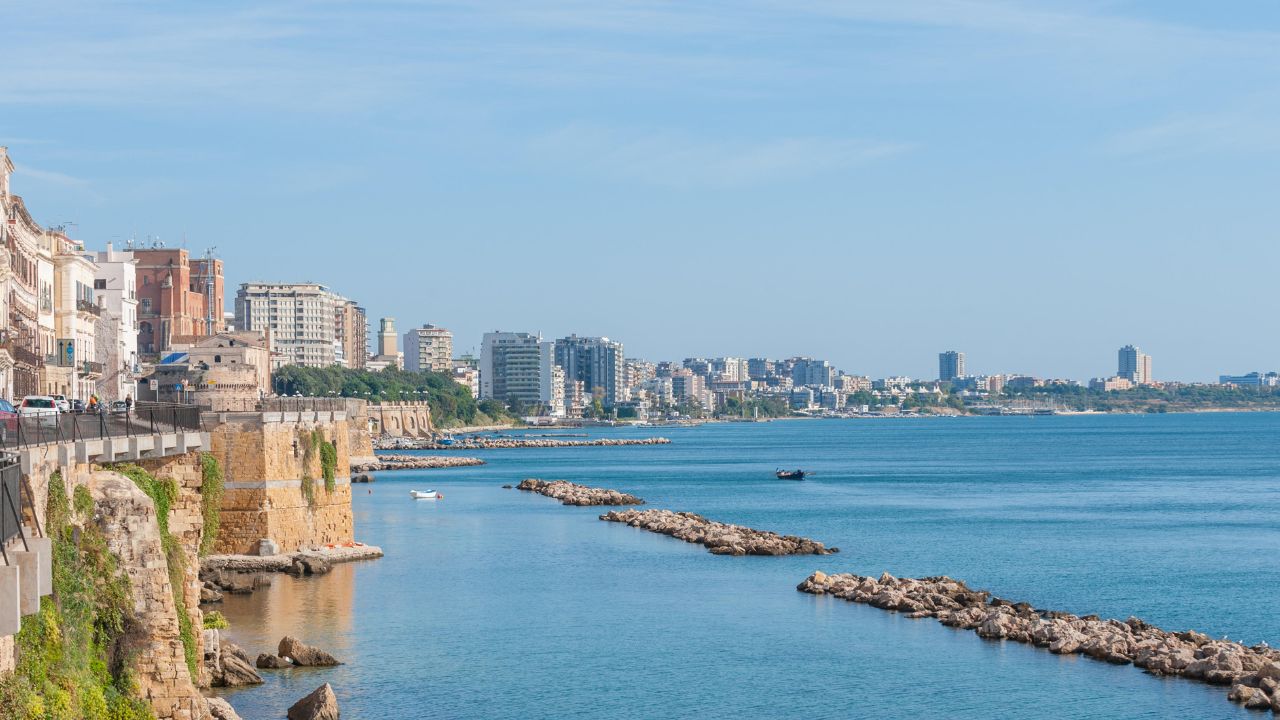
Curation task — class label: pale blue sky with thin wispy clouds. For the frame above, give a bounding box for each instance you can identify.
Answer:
[0,0,1280,380]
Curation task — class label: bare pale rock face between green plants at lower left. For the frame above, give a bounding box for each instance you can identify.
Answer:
[90,471,209,720]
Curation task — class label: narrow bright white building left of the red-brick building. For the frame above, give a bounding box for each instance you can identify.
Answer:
[93,242,141,401]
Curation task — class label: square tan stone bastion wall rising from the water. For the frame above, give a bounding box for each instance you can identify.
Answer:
[205,410,355,555]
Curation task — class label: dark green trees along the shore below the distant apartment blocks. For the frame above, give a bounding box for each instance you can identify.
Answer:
[271,365,511,428]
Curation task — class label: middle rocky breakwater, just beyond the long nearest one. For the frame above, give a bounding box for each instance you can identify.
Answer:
[600,510,840,555]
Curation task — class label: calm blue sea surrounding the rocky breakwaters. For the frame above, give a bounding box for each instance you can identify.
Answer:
[215,414,1280,720]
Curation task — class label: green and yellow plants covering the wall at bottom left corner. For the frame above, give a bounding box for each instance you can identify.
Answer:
[0,473,152,720]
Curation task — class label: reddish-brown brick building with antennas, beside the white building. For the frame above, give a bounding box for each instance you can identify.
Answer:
[136,242,224,355]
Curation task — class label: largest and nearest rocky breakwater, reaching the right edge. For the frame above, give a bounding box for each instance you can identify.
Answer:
[796,573,1280,712]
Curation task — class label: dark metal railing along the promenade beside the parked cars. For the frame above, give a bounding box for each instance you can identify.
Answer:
[0,402,204,450]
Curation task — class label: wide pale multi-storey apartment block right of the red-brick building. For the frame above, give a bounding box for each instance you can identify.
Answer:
[236,282,367,368]
